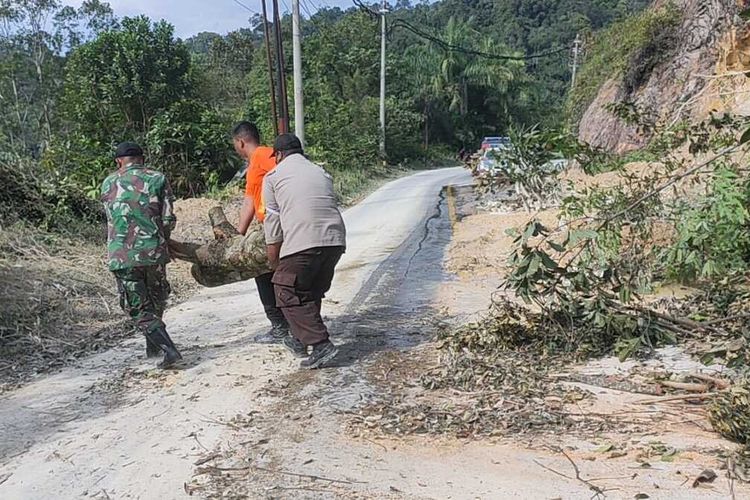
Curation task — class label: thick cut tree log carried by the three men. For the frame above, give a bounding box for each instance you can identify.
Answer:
[169,207,271,287]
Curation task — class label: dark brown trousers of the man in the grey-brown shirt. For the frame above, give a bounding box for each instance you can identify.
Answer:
[272,247,344,345]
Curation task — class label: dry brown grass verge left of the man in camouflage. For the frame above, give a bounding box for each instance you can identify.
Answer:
[0,224,130,392]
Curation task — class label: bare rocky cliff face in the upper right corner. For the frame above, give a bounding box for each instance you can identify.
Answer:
[579,0,750,153]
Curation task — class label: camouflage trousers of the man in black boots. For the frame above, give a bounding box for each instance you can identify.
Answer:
[112,264,172,346]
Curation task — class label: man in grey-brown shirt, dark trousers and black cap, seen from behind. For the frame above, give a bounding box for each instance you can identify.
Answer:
[263,134,346,369]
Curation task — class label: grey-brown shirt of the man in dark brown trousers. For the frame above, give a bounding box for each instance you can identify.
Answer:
[263,154,346,258]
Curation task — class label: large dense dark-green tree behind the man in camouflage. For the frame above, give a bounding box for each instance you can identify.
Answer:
[51,17,235,196]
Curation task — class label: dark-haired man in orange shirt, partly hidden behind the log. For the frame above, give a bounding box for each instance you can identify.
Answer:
[232,122,289,342]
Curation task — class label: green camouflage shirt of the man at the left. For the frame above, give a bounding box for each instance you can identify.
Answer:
[101,163,177,271]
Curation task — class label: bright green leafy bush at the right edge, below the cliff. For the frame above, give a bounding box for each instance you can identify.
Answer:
[666,164,750,282]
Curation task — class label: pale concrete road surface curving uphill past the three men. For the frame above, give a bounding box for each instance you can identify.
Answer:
[0,168,470,499]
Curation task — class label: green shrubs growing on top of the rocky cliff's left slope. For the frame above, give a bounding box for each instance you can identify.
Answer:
[567,4,680,127]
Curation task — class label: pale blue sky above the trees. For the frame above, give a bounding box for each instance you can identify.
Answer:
[63,0,353,38]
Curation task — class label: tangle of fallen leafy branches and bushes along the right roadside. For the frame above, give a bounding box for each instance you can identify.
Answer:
[505,108,750,363]
